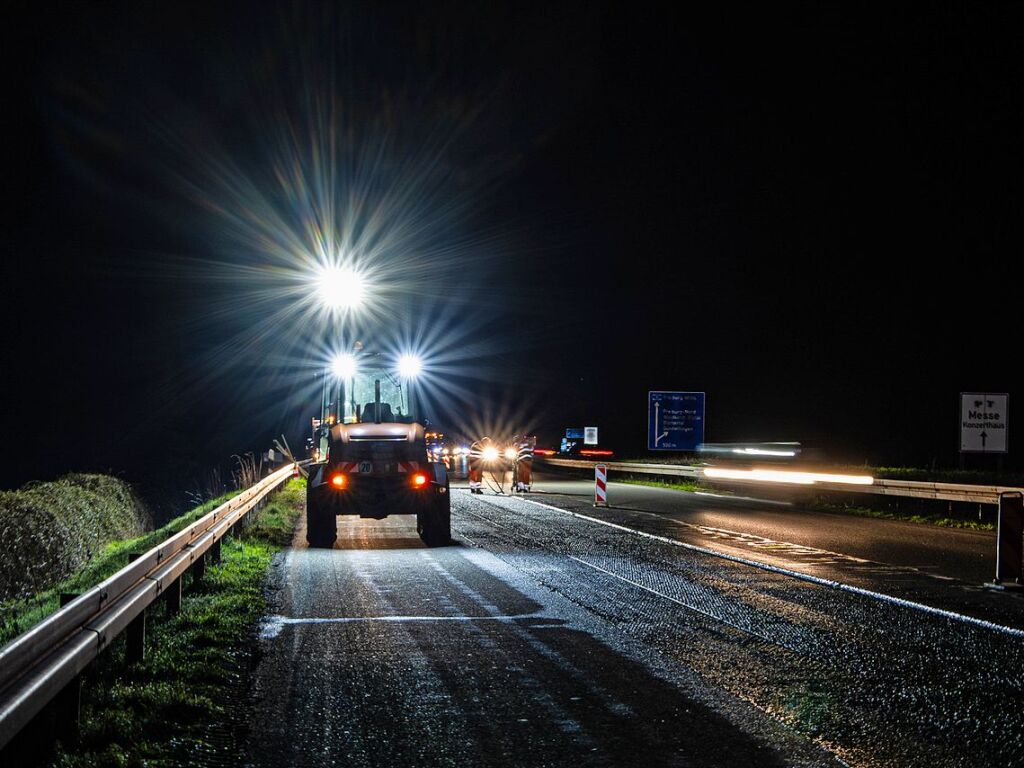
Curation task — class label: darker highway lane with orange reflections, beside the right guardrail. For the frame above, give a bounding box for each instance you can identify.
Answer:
[520,472,1024,629]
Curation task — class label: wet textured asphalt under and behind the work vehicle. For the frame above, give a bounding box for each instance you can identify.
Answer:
[246,490,1024,766]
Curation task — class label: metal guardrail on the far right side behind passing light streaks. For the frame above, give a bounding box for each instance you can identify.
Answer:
[537,456,1022,504]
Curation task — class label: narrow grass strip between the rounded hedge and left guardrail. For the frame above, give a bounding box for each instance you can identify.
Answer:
[0,494,234,645]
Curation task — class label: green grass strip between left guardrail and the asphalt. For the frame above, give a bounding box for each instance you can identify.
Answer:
[51,479,305,768]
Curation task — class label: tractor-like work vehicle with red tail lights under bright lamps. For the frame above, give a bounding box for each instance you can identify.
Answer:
[306,355,452,547]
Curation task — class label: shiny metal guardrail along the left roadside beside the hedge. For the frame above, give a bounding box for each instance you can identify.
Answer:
[0,464,295,749]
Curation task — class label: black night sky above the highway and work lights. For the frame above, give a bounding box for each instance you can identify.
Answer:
[0,2,1024,505]
